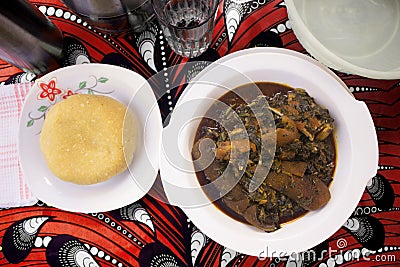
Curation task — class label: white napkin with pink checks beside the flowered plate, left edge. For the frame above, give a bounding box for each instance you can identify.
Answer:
[0,83,37,208]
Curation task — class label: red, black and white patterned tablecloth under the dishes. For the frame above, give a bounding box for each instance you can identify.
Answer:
[0,0,400,267]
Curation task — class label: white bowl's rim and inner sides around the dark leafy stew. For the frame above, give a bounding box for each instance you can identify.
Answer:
[160,48,378,257]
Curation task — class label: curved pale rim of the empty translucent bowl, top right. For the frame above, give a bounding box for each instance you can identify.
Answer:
[285,0,400,80]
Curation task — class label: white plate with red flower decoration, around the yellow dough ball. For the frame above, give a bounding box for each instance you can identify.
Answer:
[18,64,162,212]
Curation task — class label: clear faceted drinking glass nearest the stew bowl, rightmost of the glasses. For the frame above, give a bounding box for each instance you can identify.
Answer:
[152,0,219,58]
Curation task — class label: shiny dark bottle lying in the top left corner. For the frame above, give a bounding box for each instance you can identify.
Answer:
[0,0,63,75]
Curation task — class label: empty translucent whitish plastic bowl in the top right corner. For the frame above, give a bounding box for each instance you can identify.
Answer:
[285,0,400,79]
